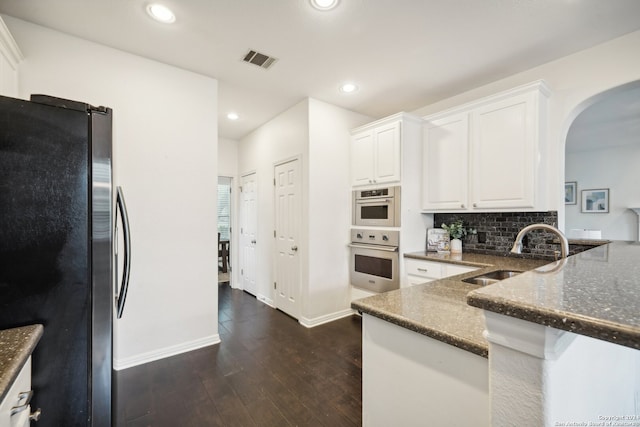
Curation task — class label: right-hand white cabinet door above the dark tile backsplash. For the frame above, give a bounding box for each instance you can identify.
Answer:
[469,93,539,209]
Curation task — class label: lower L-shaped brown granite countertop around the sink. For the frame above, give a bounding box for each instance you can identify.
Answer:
[351,251,549,357]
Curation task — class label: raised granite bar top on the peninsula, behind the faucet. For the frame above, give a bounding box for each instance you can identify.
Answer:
[468,242,640,349]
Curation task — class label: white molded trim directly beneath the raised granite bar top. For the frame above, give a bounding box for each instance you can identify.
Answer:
[484,310,576,360]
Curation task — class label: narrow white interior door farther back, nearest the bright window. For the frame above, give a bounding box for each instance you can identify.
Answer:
[240,173,258,296]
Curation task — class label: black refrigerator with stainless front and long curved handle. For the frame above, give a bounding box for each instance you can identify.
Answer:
[0,95,130,427]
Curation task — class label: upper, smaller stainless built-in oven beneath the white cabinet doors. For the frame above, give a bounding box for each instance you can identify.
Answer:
[352,186,400,227]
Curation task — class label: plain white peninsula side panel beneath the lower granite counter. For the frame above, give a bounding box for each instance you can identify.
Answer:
[362,314,488,427]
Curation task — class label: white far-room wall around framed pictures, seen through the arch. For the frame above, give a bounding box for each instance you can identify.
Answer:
[565,144,640,240]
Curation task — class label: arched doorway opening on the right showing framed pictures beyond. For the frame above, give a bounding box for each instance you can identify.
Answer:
[564,81,640,240]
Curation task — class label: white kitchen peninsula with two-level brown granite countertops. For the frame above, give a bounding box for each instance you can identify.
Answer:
[352,242,640,426]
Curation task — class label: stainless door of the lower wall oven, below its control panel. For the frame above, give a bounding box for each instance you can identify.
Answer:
[349,243,400,292]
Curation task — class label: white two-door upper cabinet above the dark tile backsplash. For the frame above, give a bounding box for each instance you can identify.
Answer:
[422,81,549,211]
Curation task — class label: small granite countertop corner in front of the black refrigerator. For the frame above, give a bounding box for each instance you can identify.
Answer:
[0,325,44,401]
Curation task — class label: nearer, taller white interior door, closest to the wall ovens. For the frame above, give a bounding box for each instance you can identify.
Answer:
[274,159,302,319]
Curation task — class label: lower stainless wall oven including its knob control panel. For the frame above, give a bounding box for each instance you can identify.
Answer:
[349,229,400,292]
